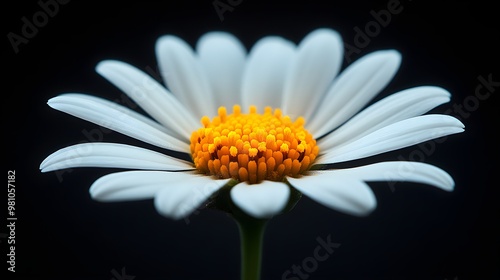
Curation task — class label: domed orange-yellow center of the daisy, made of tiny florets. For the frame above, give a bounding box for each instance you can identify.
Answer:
[190,105,319,184]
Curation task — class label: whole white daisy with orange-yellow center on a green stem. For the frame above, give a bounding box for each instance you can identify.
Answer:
[40,29,464,279]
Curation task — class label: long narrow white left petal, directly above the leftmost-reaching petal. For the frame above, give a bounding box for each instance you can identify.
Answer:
[48,93,189,153]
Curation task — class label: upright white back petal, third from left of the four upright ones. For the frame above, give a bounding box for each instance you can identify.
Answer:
[242,37,295,112]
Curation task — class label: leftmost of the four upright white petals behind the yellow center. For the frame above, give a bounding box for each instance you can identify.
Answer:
[156,35,217,118]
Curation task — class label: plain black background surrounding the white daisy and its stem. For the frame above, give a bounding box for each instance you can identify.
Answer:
[0,0,500,280]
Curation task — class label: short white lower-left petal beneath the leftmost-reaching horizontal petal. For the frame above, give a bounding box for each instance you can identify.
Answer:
[89,171,195,202]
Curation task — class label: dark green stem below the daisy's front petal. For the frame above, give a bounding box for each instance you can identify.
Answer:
[233,216,267,280]
